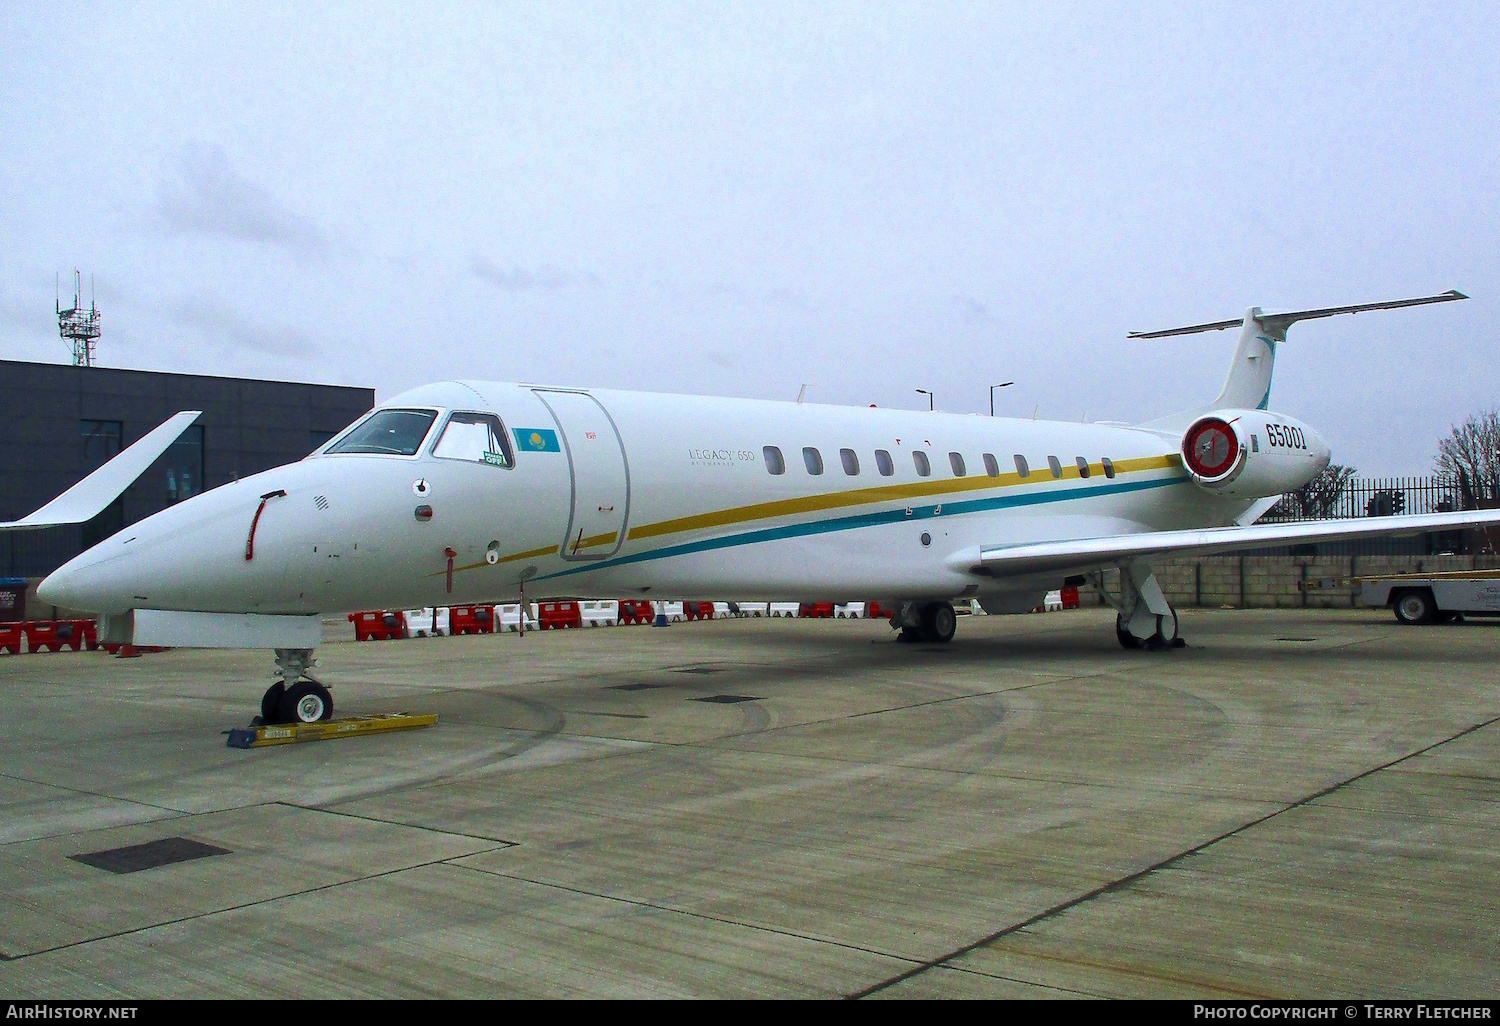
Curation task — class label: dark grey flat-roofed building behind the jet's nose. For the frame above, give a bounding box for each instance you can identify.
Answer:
[0,360,375,578]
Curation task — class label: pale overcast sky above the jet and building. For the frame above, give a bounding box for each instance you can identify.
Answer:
[0,0,1500,474]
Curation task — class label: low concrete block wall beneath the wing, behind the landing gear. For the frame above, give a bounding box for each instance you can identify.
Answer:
[1079,555,1500,609]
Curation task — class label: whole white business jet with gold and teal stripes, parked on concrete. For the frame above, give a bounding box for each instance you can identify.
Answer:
[14,293,1500,722]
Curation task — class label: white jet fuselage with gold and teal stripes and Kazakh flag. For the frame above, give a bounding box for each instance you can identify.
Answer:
[42,381,1278,614]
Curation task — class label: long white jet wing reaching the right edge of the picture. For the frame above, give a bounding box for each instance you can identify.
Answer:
[969,510,1500,578]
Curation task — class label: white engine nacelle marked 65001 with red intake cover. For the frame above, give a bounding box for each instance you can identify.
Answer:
[1182,410,1331,498]
